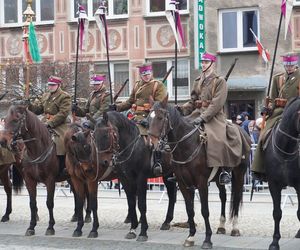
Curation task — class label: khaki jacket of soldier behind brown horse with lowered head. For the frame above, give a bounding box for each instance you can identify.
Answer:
[75,86,110,119]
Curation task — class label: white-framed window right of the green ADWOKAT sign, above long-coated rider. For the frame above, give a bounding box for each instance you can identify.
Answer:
[219,9,259,52]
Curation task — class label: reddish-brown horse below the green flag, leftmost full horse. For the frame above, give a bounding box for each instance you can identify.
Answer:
[0,103,88,236]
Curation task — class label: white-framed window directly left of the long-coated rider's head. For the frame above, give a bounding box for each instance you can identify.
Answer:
[152,59,190,99]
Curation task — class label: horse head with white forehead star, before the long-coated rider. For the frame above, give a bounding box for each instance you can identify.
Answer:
[148,96,173,147]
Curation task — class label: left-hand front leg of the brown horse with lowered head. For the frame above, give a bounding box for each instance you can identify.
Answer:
[71,176,85,237]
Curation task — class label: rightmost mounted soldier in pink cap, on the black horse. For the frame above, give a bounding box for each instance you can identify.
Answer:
[252,53,300,181]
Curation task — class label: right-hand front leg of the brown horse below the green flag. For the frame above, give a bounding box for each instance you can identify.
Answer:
[45,178,55,235]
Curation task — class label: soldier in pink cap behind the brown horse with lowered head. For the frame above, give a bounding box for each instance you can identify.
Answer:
[72,75,109,129]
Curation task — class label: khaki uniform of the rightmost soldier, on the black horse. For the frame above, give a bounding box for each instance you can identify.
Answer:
[252,68,300,173]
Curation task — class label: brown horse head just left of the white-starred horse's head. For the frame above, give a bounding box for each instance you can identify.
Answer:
[93,112,119,167]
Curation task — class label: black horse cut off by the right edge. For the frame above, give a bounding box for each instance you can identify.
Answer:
[264,97,300,250]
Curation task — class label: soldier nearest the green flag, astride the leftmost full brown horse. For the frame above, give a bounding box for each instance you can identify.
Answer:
[28,76,72,177]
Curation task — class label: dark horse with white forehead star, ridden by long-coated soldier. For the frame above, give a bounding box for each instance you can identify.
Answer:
[148,97,250,249]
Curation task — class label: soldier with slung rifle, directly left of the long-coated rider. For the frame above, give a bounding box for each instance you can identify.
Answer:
[110,63,167,175]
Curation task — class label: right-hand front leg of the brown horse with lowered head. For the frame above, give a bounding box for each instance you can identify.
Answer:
[84,181,99,238]
